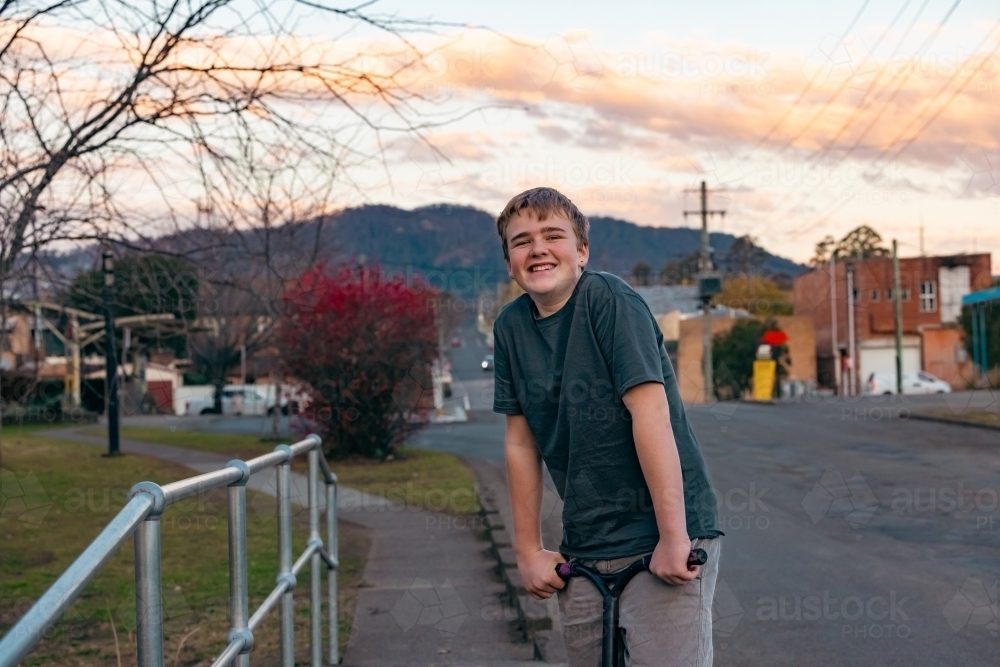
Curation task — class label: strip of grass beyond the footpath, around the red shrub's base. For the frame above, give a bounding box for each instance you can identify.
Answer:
[84,426,479,514]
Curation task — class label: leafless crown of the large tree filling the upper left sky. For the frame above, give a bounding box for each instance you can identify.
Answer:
[0,0,468,446]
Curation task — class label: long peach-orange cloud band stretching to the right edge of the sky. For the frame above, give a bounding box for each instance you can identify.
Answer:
[402,34,1000,170]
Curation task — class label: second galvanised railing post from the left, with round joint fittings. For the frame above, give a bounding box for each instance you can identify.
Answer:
[226,461,253,667]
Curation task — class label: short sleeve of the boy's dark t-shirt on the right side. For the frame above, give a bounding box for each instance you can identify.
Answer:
[595,293,663,396]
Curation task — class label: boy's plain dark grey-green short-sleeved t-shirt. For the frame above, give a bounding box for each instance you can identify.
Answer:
[493,271,722,559]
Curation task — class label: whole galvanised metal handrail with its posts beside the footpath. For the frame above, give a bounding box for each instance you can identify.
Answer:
[0,435,340,667]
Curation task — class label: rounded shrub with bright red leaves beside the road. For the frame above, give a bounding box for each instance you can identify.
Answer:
[278,265,437,457]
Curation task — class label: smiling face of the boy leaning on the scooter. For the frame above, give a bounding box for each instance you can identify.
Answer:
[507,211,590,317]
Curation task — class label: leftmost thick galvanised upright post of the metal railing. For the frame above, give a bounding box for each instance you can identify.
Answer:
[131,482,166,667]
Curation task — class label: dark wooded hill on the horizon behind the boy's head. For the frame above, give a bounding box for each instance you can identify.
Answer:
[39,204,806,298]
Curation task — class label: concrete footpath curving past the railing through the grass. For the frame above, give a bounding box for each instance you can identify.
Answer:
[51,429,539,667]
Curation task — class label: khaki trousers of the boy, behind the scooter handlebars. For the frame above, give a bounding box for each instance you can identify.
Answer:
[558,538,721,667]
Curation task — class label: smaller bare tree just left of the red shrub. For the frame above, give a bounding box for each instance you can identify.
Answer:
[188,143,340,436]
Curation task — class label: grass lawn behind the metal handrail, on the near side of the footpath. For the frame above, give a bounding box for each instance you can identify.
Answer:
[0,427,370,667]
